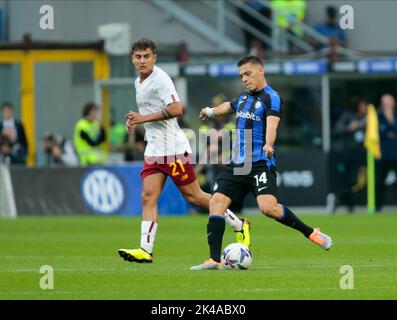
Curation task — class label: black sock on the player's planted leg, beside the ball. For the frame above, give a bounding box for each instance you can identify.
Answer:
[207,216,225,262]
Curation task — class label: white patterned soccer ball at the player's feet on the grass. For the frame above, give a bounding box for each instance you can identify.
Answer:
[222,243,252,269]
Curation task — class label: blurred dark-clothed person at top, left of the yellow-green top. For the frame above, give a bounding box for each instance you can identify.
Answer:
[238,0,272,59]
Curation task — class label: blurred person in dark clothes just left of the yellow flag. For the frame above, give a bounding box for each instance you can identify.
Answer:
[327,97,367,212]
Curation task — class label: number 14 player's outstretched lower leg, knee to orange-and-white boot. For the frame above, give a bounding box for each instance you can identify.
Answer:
[257,195,332,250]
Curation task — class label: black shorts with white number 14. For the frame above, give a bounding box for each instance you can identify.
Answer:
[213,161,277,207]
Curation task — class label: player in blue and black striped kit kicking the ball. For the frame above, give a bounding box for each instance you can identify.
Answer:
[191,56,332,270]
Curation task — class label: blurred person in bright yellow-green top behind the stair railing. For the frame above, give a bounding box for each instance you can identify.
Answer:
[270,0,306,53]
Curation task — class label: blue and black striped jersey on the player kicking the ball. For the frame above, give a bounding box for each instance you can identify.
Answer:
[230,85,283,167]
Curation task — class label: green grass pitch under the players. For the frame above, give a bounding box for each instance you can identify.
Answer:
[0,214,397,300]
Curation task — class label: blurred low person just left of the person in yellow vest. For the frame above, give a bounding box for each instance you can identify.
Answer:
[43,133,79,167]
